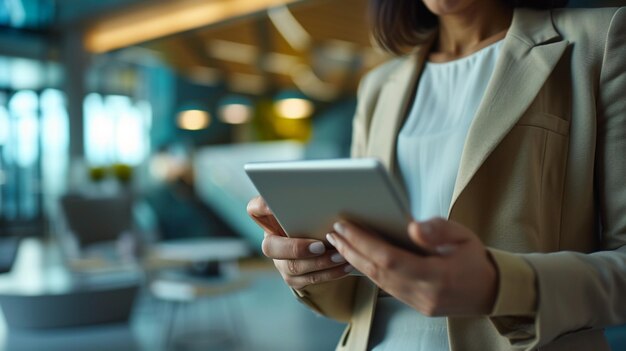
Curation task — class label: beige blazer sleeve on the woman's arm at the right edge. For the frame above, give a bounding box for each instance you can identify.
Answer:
[492,8,626,350]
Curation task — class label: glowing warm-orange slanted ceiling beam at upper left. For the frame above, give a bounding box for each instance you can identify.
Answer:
[85,0,305,53]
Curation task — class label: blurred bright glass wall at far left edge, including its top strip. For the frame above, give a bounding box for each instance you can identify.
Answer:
[0,57,64,233]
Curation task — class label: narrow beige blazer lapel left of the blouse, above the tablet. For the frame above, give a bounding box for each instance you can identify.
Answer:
[367,35,434,173]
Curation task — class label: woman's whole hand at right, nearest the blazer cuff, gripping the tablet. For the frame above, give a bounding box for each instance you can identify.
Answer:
[327,218,498,316]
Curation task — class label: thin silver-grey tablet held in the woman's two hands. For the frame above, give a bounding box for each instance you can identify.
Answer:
[244,158,415,248]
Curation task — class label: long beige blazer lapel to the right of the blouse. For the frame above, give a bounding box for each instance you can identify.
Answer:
[449,9,568,213]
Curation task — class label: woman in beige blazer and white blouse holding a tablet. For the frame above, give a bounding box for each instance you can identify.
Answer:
[248,0,626,351]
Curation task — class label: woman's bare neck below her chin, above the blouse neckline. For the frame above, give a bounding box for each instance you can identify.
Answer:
[437,0,513,56]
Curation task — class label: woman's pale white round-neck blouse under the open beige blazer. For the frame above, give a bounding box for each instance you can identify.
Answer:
[369,40,502,351]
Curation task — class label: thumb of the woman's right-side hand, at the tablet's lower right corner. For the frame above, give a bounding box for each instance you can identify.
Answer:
[408,218,472,256]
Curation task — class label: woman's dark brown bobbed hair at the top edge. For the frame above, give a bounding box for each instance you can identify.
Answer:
[370,0,568,54]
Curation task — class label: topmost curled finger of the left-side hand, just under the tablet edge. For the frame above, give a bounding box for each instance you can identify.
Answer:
[261,234,326,260]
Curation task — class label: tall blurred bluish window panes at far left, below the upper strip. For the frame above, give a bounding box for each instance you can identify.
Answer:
[0,89,69,223]
